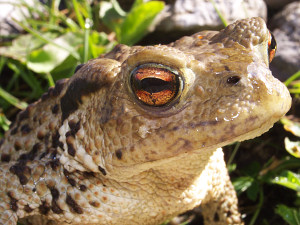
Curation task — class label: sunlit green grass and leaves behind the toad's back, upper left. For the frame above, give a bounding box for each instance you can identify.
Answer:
[0,0,164,136]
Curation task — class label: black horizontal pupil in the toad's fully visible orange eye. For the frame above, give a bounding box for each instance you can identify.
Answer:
[140,78,172,94]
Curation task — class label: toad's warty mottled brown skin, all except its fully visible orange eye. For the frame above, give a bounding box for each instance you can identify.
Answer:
[0,18,291,224]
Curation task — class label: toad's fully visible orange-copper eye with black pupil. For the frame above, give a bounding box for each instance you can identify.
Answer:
[130,63,182,106]
